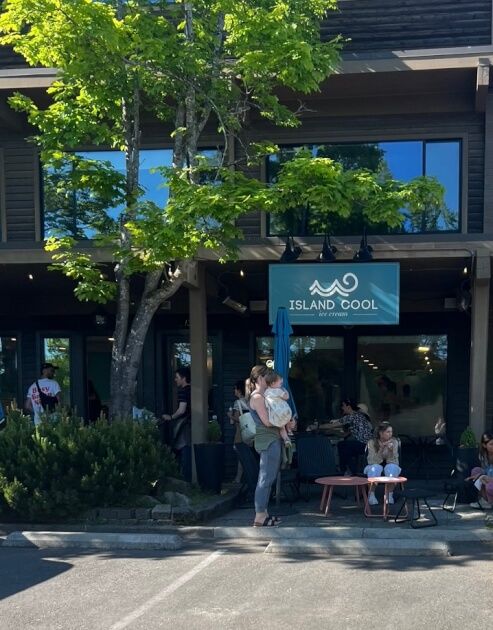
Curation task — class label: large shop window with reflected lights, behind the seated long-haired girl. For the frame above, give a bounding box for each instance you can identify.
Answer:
[358,335,447,435]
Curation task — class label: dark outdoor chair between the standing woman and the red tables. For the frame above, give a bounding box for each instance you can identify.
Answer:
[296,433,338,501]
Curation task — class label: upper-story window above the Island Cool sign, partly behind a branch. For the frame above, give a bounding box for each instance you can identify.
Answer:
[267,140,461,236]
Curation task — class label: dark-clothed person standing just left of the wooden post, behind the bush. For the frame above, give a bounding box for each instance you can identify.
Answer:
[163,367,192,482]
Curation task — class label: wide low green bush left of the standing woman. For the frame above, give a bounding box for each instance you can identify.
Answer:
[0,410,179,520]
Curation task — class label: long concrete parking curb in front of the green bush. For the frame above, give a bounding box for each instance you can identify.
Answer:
[1,532,183,551]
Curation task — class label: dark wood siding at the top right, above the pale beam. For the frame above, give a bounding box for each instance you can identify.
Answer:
[321,0,491,52]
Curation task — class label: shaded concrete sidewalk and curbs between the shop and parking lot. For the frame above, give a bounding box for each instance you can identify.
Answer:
[0,482,493,555]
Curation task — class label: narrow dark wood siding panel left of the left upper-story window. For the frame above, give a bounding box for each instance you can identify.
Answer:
[4,143,38,242]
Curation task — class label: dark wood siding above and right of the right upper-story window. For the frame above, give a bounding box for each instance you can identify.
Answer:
[238,113,484,238]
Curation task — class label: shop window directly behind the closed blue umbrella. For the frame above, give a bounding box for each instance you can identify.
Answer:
[257,336,344,429]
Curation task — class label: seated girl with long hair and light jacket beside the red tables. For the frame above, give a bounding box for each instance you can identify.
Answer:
[363,422,401,505]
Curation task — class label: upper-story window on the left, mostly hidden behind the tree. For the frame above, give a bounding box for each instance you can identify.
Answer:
[43,149,222,240]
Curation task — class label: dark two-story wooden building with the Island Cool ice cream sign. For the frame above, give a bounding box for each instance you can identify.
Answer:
[0,0,493,478]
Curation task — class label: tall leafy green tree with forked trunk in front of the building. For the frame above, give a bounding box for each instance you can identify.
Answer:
[0,0,442,415]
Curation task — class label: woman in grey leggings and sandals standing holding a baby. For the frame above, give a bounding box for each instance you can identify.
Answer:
[247,365,295,527]
